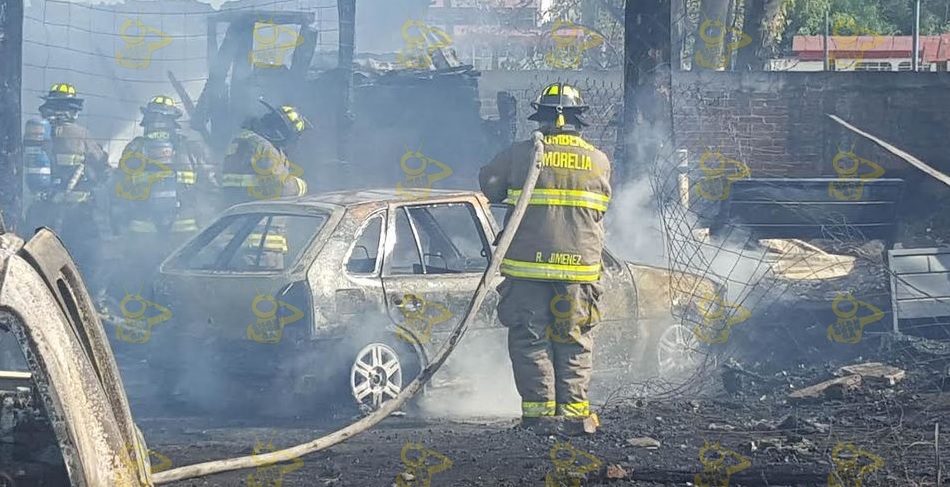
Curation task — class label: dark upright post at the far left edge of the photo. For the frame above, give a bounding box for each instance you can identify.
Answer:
[0,0,23,230]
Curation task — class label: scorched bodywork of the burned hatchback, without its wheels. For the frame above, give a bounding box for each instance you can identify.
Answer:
[156,190,720,412]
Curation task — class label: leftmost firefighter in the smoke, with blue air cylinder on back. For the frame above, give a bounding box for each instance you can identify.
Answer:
[24,83,112,284]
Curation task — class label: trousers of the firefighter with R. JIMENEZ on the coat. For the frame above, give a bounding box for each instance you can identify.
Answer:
[498,278,601,419]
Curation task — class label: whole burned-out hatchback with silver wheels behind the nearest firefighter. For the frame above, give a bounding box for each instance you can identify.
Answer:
[149,190,716,412]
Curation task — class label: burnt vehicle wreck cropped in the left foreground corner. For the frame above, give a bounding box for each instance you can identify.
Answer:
[0,228,152,487]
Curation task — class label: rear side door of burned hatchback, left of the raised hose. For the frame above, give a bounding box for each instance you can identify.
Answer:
[382,200,493,352]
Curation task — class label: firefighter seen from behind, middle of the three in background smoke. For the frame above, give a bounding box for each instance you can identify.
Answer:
[115,95,210,270]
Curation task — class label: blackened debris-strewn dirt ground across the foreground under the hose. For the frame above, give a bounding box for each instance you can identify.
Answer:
[138,332,950,487]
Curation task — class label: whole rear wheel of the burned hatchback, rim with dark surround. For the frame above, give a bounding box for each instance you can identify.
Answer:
[349,341,419,412]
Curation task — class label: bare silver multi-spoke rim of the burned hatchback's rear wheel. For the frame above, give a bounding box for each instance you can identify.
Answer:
[350,343,402,411]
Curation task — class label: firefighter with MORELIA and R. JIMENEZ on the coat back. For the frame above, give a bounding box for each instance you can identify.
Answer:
[479,83,611,435]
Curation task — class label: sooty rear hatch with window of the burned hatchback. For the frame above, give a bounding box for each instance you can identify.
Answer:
[156,210,328,341]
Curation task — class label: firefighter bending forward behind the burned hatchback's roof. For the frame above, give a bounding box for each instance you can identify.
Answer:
[219,100,310,270]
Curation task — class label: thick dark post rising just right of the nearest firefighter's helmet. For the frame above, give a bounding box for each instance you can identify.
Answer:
[615,0,675,181]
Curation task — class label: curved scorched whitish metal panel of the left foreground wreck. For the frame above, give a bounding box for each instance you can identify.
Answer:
[0,228,152,487]
